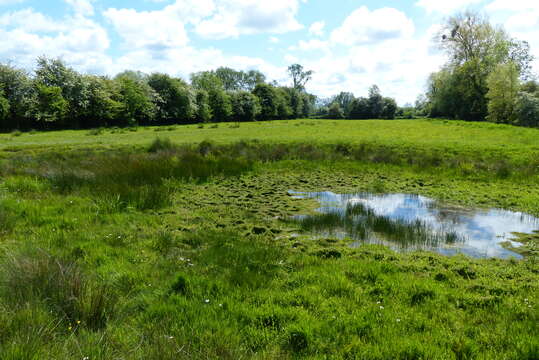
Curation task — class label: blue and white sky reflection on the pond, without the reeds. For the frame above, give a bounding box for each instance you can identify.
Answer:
[291,191,539,258]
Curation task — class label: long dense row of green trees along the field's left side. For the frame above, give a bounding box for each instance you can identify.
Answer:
[0,57,316,131]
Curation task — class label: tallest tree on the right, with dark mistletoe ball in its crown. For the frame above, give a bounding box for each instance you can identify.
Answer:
[427,11,533,121]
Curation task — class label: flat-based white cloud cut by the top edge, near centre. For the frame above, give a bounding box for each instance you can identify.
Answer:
[196,0,303,39]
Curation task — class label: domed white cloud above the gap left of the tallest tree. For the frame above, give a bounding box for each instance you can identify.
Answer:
[331,6,415,46]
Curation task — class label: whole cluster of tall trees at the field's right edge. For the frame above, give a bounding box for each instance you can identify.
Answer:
[416,11,539,127]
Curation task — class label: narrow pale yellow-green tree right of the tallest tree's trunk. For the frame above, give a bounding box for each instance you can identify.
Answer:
[487,63,519,124]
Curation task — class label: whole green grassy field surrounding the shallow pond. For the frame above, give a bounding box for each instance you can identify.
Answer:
[0,120,539,359]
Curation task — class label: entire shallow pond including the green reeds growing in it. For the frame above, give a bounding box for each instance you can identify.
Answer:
[290,191,539,258]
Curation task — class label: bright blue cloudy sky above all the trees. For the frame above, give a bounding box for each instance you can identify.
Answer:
[0,0,539,105]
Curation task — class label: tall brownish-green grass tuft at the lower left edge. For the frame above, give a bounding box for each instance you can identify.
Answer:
[0,250,114,330]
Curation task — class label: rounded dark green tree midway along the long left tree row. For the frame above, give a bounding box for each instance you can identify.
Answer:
[147,73,195,124]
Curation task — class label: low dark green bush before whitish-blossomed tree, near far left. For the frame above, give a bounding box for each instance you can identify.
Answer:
[34,83,69,128]
